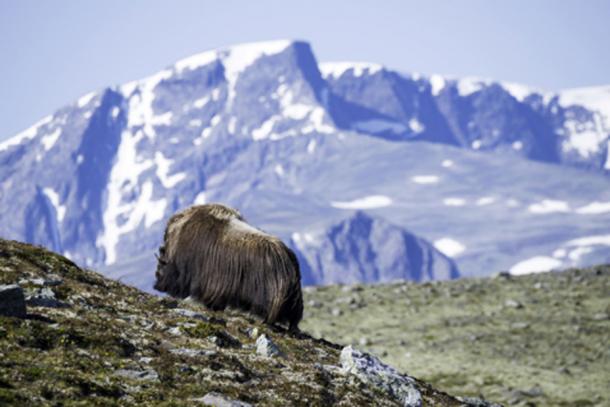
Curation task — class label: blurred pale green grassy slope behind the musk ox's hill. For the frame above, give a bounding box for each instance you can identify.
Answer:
[302,266,610,406]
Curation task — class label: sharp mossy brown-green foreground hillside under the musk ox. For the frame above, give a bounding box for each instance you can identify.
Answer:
[0,239,459,406]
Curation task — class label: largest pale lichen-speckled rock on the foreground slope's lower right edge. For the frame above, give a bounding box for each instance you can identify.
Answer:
[340,346,423,407]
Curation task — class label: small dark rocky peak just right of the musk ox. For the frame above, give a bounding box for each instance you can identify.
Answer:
[291,211,459,285]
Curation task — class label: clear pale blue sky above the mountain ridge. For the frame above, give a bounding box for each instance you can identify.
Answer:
[0,0,610,140]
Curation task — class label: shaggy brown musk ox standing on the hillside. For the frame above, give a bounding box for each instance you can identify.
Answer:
[155,204,303,330]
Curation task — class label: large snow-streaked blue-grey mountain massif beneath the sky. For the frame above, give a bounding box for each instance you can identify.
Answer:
[0,41,610,288]
